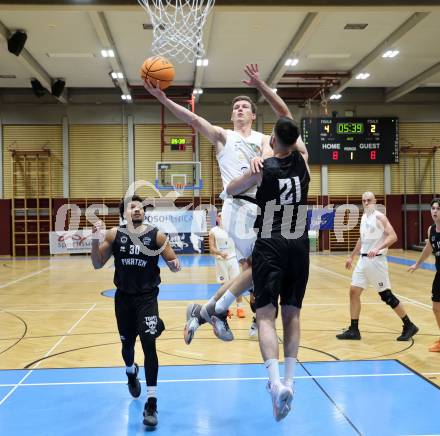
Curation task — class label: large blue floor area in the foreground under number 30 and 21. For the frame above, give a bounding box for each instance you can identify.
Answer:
[0,360,440,436]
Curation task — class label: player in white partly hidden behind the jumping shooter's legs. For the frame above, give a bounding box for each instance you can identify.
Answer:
[209,212,246,318]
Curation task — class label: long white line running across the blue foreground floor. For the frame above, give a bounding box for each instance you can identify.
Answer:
[0,372,417,388]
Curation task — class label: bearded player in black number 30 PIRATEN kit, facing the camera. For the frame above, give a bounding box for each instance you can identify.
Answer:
[92,195,180,427]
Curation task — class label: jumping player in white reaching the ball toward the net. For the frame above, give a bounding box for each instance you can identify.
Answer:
[144,65,291,343]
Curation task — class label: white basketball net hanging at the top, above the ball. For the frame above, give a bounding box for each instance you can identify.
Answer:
[138,0,215,63]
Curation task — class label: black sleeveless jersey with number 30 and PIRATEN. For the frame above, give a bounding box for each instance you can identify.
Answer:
[113,226,160,298]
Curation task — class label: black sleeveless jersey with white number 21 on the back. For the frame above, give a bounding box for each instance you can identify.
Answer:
[255,151,310,238]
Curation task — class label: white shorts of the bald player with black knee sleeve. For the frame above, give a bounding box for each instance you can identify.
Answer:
[351,255,391,292]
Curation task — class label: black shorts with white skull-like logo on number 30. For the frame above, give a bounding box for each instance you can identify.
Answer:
[115,290,165,341]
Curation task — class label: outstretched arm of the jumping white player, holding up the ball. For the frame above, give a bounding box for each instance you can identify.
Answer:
[144,81,226,153]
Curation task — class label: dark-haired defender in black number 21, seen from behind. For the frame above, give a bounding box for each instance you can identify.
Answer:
[227,117,310,421]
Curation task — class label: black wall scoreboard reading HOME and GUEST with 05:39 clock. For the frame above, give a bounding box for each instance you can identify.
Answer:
[301,118,399,164]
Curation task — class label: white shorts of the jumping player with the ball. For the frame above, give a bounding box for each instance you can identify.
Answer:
[222,198,258,262]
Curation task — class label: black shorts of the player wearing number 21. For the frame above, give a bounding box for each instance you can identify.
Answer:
[252,235,309,309]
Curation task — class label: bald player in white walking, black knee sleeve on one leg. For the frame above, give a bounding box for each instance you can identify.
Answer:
[336,192,419,341]
